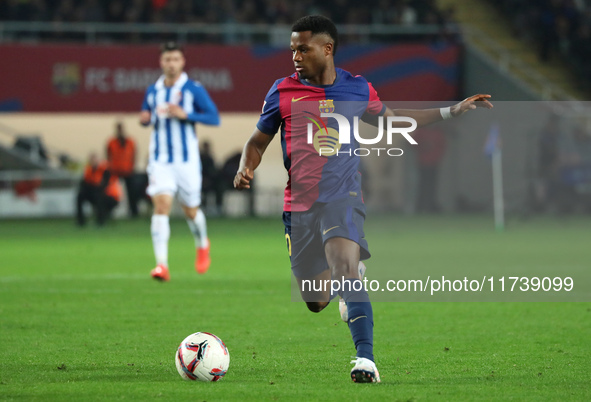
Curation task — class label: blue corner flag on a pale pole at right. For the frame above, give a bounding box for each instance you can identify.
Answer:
[484,123,505,232]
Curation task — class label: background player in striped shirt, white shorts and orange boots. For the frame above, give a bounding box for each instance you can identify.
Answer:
[140,42,220,281]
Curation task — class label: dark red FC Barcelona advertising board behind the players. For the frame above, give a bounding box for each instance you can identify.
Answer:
[0,44,460,112]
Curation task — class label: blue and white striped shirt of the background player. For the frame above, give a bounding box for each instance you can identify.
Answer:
[142,73,220,163]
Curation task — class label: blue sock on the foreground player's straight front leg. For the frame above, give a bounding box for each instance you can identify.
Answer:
[340,279,374,361]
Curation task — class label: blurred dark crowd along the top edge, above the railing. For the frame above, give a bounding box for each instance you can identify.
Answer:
[0,0,446,25]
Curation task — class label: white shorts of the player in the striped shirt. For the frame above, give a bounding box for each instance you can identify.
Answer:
[146,162,201,208]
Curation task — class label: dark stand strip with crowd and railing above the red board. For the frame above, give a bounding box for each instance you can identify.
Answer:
[0,0,454,45]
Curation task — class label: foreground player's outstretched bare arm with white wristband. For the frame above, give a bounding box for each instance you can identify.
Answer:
[384,94,493,127]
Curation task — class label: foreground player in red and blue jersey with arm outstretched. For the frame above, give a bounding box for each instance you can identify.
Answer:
[234,16,492,382]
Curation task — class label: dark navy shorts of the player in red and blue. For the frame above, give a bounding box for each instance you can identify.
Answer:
[283,195,370,278]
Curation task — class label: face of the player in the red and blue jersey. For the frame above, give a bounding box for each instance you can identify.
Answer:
[291,31,332,80]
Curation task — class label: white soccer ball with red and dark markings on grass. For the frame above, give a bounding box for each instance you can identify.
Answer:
[175,332,230,381]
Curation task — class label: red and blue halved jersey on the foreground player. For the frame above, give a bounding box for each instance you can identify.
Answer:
[257,68,386,212]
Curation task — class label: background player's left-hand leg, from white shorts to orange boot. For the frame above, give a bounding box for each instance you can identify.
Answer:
[146,163,177,281]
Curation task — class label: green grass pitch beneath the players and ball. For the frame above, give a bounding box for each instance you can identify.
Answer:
[0,215,591,401]
